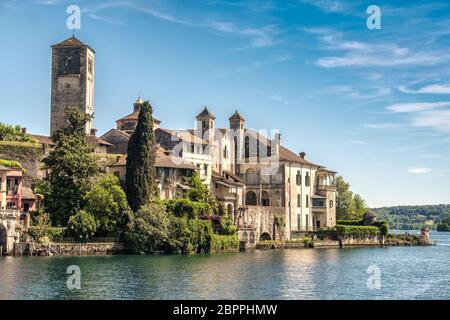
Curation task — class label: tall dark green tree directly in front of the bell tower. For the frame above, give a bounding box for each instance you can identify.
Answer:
[38,107,101,226]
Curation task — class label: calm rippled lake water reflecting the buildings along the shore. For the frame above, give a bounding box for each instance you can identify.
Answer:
[0,232,450,299]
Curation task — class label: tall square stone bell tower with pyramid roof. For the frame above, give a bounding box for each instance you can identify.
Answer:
[50,36,95,134]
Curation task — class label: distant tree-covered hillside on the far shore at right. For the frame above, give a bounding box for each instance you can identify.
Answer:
[372,204,450,230]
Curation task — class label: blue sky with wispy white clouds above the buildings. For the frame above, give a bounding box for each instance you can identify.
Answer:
[0,0,450,207]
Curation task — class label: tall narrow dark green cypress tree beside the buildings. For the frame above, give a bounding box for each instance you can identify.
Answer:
[125,101,157,212]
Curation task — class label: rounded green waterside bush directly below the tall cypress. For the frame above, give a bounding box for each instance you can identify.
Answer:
[125,202,170,253]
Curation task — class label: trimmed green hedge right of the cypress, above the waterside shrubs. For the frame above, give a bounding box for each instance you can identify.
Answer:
[163,198,212,219]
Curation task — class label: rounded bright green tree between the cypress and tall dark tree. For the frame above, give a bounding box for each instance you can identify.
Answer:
[85,174,131,236]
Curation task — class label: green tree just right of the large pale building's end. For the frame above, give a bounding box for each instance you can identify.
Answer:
[336,176,368,220]
